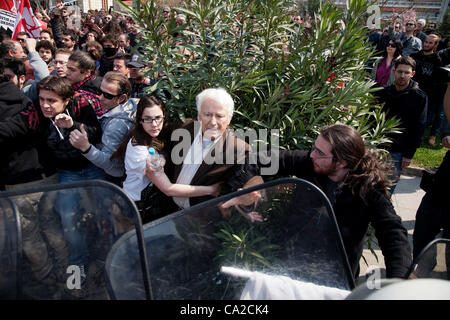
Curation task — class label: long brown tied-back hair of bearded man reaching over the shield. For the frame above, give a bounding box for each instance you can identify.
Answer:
[320,124,391,201]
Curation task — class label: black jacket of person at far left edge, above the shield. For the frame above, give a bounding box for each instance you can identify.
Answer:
[0,82,55,184]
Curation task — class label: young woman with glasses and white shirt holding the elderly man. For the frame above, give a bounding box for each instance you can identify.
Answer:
[111,95,220,223]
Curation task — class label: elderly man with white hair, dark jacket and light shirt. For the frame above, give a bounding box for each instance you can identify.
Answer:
[154,88,262,209]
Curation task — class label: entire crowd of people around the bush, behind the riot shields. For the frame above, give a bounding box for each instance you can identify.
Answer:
[0,2,450,298]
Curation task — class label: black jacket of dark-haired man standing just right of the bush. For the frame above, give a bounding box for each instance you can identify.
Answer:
[377,80,428,159]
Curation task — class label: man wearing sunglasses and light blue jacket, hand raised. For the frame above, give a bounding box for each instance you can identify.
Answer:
[70,71,137,186]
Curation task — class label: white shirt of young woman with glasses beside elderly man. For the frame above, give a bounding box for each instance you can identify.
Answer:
[123,139,151,201]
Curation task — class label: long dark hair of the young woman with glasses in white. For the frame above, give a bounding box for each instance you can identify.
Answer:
[111,95,170,160]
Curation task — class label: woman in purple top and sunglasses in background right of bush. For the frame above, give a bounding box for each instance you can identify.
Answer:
[371,38,403,87]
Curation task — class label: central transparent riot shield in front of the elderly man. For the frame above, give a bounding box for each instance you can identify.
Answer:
[106,179,354,300]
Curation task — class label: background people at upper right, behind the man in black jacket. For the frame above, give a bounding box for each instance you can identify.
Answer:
[368,17,450,146]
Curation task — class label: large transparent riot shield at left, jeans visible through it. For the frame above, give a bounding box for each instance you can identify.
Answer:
[0,180,150,300]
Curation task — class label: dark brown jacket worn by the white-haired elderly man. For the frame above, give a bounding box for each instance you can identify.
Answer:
[166,119,255,206]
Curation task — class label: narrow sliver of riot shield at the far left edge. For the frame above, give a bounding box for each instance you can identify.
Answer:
[0,198,21,299]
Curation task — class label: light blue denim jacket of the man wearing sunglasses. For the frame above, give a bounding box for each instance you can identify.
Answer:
[84,99,137,177]
